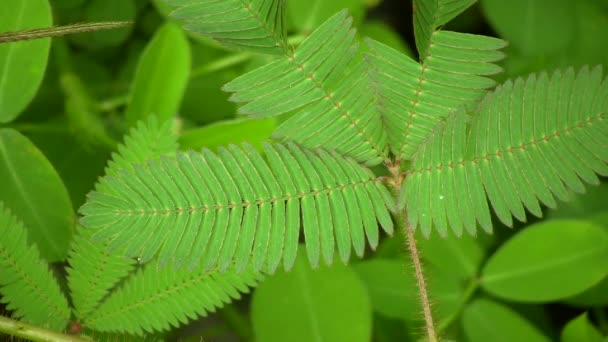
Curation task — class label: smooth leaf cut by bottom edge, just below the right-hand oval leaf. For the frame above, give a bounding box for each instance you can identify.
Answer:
[462,298,550,342]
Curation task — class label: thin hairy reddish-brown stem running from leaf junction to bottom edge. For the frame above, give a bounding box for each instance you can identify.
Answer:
[403,214,439,342]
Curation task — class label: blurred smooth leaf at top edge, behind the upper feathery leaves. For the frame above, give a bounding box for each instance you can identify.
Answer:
[286,0,365,33]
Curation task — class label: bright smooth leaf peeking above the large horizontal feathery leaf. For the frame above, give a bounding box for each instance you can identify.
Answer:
[179,118,277,151]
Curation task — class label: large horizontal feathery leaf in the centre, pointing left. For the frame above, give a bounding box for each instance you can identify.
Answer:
[80,143,393,272]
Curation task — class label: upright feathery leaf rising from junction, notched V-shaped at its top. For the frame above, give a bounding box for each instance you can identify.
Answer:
[368,31,505,160]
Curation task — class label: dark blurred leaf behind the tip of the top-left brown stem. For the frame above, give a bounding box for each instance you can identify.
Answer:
[70,0,136,49]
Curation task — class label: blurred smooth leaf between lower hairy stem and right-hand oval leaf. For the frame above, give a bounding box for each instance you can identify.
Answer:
[418,230,485,280]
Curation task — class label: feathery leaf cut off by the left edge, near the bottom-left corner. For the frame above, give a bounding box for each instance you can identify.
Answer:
[0,202,70,331]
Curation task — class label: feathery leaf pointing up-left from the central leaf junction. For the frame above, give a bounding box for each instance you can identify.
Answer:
[224,11,388,165]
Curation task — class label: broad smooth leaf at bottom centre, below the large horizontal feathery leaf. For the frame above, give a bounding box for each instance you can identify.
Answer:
[251,248,372,342]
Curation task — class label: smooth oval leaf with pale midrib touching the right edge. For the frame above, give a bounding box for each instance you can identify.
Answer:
[481,220,608,302]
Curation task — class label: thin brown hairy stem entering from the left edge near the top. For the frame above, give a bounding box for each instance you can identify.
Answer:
[0,21,131,44]
